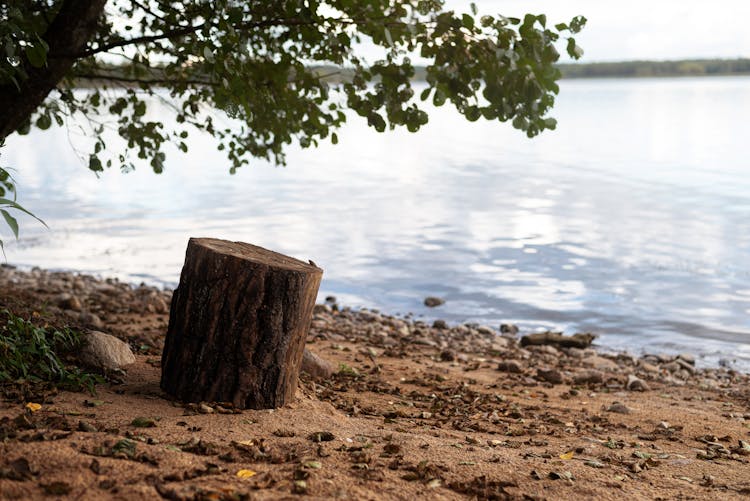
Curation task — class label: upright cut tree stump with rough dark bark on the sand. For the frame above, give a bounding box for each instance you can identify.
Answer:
[161,238,323,409]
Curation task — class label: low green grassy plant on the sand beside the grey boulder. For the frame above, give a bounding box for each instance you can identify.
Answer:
[0,310,104,394]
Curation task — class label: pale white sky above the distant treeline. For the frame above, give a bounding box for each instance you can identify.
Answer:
[446,0,750,62]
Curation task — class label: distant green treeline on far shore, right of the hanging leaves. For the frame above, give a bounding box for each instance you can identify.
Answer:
[558,59,750,78]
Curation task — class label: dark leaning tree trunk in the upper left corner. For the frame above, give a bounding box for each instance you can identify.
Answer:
[0,0,106,141]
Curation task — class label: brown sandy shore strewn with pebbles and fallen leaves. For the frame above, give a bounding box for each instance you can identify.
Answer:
[0,267,750,500]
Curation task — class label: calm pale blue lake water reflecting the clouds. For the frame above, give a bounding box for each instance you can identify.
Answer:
[0,77,750,367]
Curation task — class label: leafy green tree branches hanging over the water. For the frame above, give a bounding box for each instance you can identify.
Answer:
[0,0,585,172]
